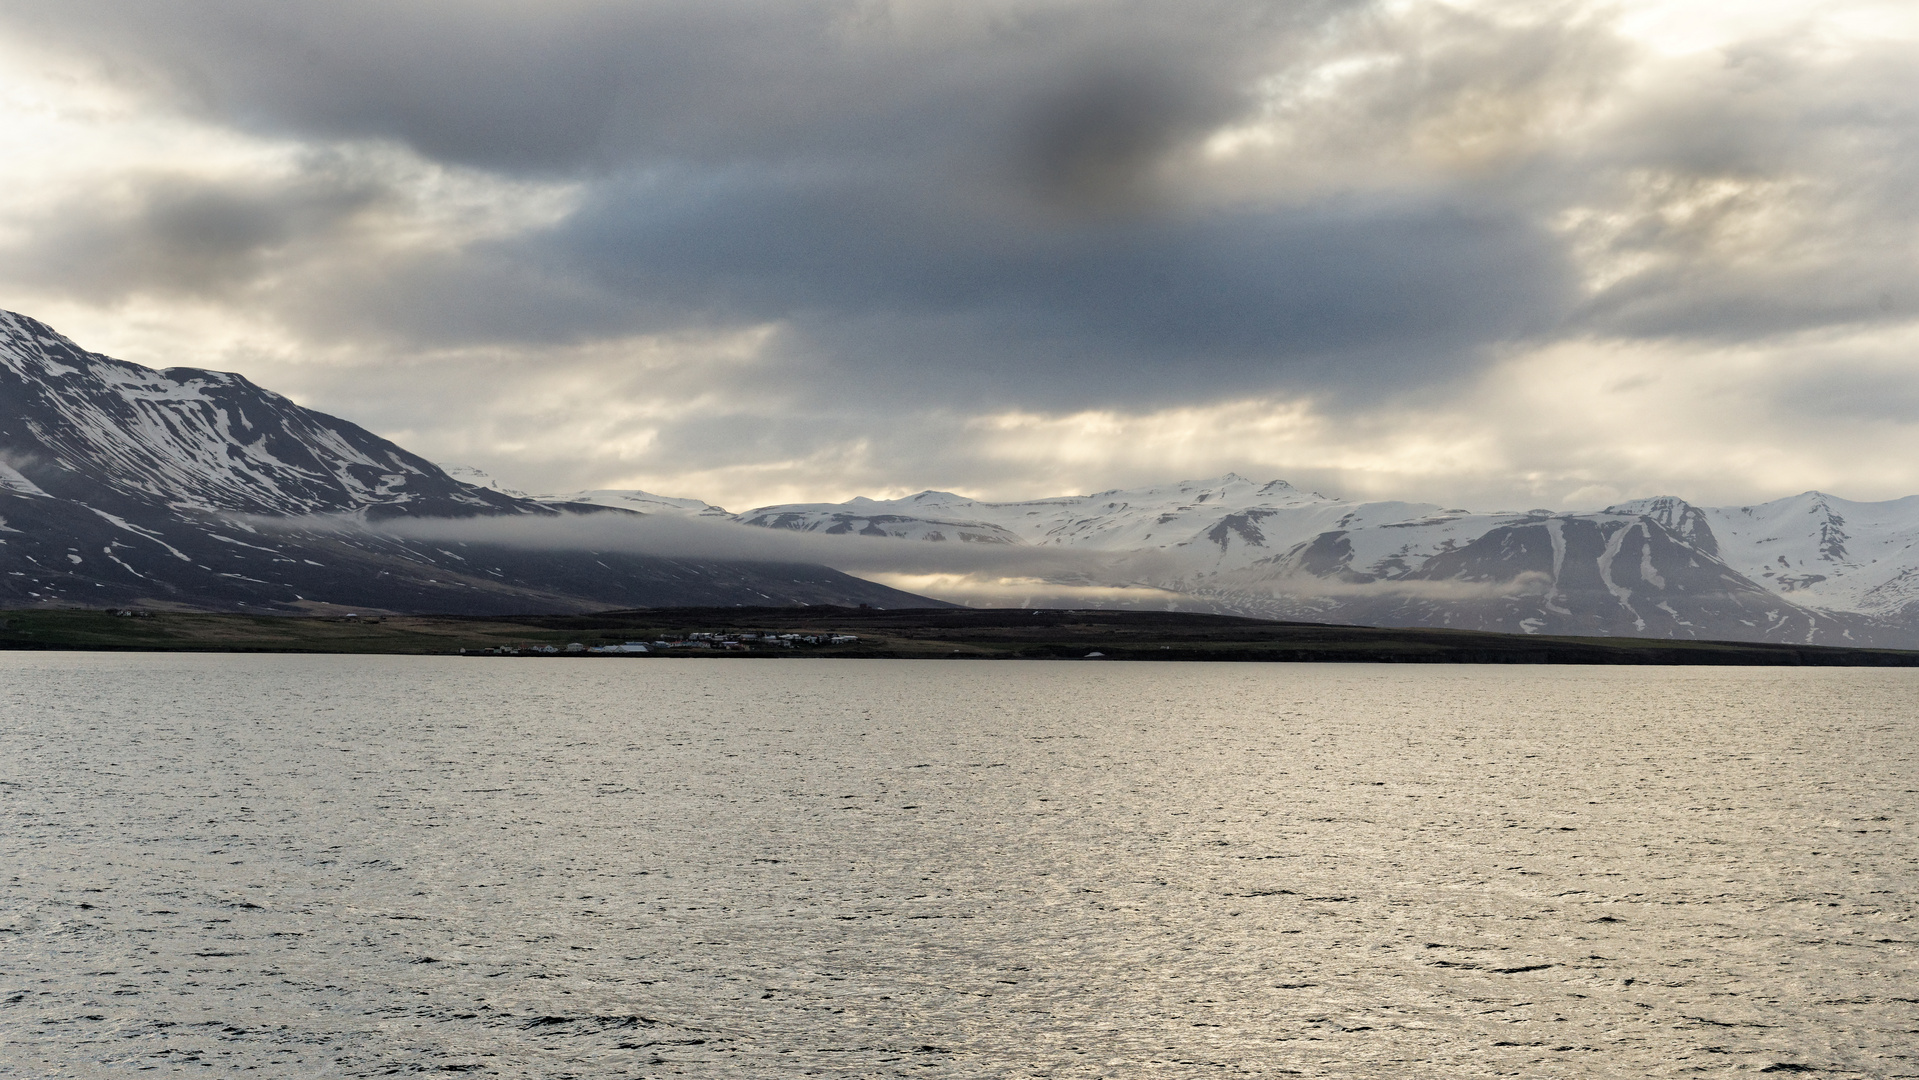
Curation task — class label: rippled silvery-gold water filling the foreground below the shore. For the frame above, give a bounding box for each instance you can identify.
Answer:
[0,654,1919,1078]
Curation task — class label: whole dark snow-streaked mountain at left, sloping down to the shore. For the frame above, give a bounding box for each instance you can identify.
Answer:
[0,313,929,614]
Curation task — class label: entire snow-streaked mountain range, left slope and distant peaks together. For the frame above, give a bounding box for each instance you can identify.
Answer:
[18,303,1919,646]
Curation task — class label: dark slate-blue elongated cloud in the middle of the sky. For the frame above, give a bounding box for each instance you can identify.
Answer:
[535,173,1568,399]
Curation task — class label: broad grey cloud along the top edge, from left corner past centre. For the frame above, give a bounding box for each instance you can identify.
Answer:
[0,0,1320,173]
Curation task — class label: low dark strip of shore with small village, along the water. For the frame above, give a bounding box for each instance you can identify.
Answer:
[0,606,1919,668]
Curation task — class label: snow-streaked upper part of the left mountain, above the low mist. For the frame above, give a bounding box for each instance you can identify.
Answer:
[0,311,533,516]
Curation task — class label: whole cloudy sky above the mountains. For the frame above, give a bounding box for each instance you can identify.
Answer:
[0,0,1919,510]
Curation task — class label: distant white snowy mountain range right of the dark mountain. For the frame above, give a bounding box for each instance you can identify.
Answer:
[721,474,1919,646]
